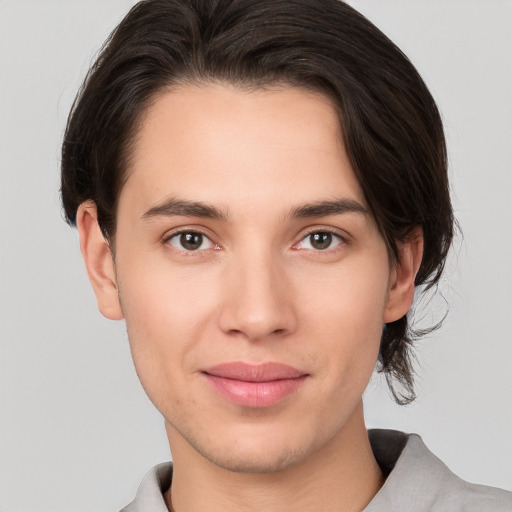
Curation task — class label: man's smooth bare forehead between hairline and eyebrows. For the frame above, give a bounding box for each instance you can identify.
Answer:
[120,84,364,216]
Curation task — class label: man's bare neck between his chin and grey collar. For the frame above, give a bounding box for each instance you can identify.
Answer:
[165,403,384,512]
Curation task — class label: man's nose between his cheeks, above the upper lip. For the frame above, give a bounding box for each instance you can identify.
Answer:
[219,249,297,341]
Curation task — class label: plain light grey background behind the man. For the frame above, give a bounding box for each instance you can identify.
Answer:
[0,0,512,512]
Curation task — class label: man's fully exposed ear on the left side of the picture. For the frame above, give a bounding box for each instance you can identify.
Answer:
[76,201,123,320]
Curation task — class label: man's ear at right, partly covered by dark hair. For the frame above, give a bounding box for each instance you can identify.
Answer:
[383,227,423,323]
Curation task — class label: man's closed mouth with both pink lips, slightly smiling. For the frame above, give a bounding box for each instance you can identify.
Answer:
[202,362,309,408]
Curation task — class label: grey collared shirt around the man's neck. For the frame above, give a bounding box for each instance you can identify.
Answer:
[121,429,512,512]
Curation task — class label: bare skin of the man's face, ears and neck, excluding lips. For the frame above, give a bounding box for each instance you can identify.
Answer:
[78,84,422,512]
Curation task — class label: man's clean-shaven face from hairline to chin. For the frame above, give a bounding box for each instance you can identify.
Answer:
[79,85,416,471]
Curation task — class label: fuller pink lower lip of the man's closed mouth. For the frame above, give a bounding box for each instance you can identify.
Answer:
[204,373,307,408]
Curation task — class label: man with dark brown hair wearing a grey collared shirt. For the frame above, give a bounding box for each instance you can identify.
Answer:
[62,0,512,512]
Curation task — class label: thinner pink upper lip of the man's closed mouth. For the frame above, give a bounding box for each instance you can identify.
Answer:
[203,361,307,382]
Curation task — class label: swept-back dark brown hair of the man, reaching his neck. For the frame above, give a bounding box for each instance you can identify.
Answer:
[62,0,453,403]
